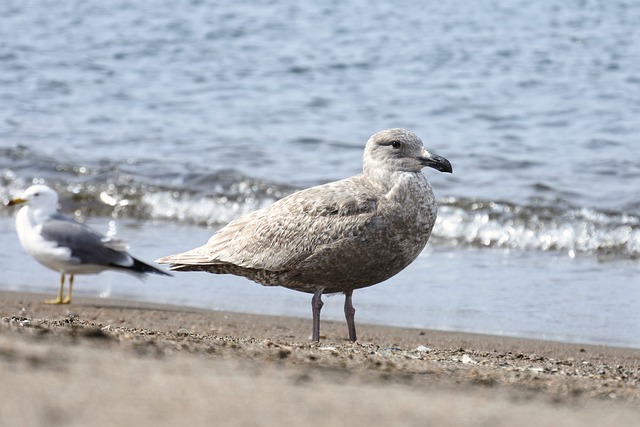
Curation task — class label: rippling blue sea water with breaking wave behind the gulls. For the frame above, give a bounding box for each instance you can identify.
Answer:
[0,0,640,347]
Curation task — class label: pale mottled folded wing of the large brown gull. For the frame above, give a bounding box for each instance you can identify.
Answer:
[158,176,379,271]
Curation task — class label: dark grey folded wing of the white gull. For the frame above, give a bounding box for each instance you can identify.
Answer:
[40,213,172,275]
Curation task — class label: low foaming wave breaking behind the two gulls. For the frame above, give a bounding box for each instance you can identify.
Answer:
[0,149,640,260]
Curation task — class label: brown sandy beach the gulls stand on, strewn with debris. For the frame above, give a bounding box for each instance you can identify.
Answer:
[0,292,640,426]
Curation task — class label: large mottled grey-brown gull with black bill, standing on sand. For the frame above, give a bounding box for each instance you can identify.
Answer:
[156,129,453,342]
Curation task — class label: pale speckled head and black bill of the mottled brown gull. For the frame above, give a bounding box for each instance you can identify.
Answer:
[364,129,453,174]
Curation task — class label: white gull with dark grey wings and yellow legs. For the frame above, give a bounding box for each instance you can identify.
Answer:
[7,185,171,304]
